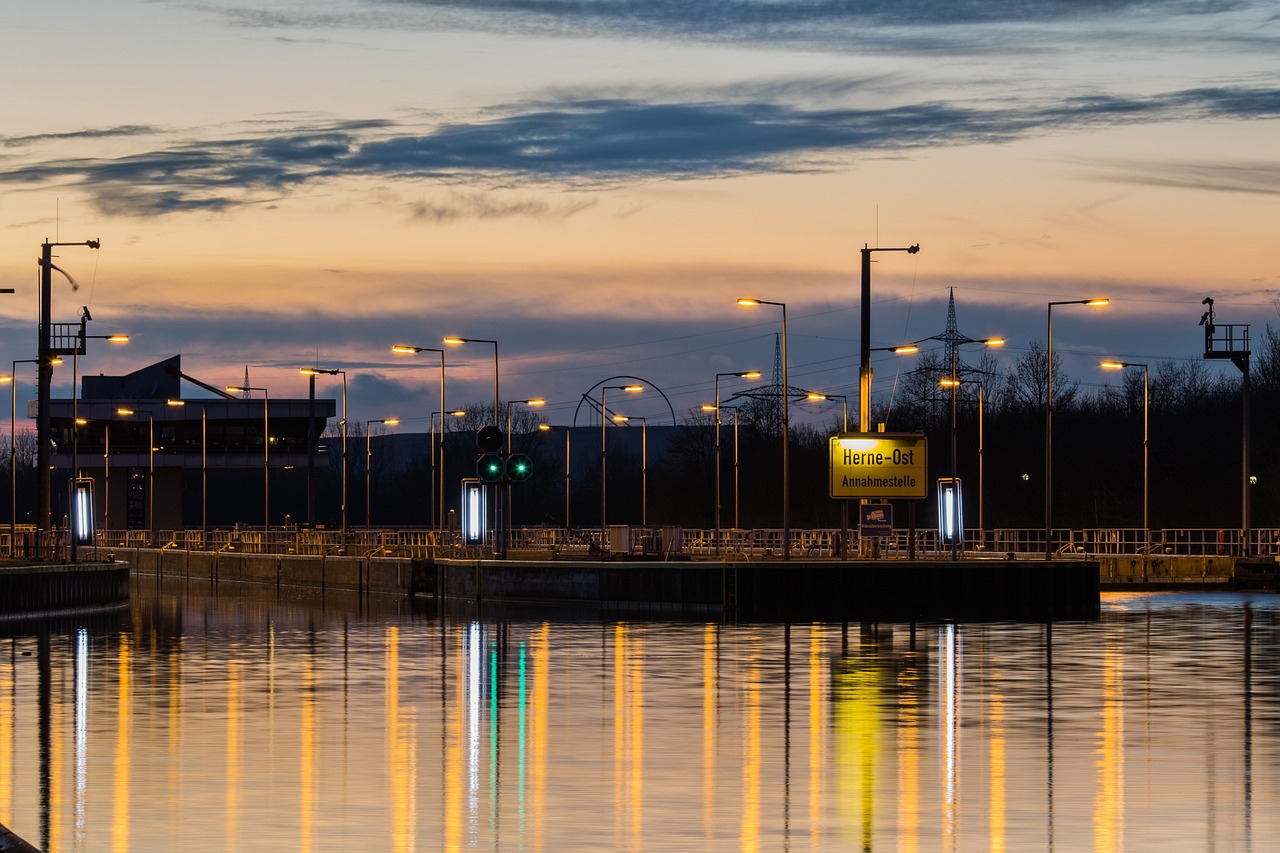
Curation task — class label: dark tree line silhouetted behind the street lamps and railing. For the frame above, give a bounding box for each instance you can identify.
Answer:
[0,325,1280,529]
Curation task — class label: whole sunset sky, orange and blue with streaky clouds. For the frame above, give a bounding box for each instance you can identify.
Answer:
[0,0,1280,432]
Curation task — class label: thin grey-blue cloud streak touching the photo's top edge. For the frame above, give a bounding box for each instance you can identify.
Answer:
[202,0,1271,54]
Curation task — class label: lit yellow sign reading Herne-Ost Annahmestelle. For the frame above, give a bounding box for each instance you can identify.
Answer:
[831,433,929,498]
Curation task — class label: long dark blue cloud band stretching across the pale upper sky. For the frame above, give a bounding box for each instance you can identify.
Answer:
[0,87,1280,213]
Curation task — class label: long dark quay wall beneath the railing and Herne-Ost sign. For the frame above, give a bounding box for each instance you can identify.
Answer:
[111,548,1259,621]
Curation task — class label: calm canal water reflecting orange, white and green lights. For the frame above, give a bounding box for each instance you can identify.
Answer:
[0,585,1280,853]
